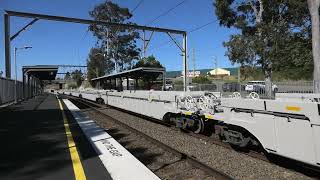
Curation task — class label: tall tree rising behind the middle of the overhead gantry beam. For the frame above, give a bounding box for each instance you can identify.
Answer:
[89,1,140,71]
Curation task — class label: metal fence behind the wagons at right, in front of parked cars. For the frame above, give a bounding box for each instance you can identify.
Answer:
[173,81,313,98]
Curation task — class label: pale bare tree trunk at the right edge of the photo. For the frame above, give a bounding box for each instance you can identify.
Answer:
[308,0,320,93]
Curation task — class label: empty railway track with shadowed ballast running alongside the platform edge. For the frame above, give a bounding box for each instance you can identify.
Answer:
[70,98,232,179]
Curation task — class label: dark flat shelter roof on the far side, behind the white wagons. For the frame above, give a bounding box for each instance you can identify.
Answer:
[91,67,166,81]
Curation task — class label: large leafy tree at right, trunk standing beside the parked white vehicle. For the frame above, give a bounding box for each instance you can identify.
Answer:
[214,0,310,96]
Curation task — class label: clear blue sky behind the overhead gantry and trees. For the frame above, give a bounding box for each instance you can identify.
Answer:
[0,0,236,77]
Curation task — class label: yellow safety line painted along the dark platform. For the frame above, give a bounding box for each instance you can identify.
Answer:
[58,99,86,180]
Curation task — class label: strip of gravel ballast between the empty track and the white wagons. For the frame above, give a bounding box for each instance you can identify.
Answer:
[95,108,312,179]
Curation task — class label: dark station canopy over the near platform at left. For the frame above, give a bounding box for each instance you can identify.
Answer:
[22,65,59,80]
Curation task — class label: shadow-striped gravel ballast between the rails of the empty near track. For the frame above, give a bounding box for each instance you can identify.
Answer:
[85,111,221,180]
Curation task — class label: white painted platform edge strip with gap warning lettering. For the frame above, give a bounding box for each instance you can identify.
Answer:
[63,99,160,180]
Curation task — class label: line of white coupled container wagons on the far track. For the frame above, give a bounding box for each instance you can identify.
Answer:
[60,90,320,167]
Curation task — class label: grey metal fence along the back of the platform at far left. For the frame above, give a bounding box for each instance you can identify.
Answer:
[0,78,42,105]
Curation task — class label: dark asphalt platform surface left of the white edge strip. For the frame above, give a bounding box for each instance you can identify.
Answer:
[0,94,112,180]
